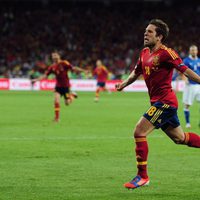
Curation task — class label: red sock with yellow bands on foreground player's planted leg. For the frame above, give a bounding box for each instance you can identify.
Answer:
[135,136,148,178]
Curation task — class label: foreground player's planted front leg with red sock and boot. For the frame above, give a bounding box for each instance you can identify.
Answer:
[124,117,155,189]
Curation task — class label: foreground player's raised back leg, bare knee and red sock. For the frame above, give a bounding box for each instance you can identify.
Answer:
[164,126,200,148]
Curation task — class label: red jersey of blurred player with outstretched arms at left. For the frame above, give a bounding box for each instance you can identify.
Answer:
[45,60,72,87]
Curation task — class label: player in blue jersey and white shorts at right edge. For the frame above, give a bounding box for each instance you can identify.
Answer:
[183,45,200,128]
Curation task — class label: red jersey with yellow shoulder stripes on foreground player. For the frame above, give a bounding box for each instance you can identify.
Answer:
[135,45,187,108]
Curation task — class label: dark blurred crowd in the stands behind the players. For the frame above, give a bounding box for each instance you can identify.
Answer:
[0,1,200,79]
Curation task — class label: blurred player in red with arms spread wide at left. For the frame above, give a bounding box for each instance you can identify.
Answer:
[34,51,86,122]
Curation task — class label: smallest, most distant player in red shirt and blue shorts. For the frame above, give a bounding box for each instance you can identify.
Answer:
[93,60,108,102]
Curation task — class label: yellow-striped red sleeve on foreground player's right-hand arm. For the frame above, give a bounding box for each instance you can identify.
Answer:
[166,49,188,73]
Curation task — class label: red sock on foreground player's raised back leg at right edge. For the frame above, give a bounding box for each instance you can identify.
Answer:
[184,133,200,148]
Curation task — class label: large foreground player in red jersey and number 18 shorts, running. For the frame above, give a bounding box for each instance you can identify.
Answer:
[116,19,200,189]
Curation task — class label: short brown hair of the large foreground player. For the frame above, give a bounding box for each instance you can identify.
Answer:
[149,19,169,42]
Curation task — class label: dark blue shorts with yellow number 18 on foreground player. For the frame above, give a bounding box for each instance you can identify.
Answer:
[143,102,180,130]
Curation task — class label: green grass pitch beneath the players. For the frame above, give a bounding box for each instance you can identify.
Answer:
[0,91,200,200]
